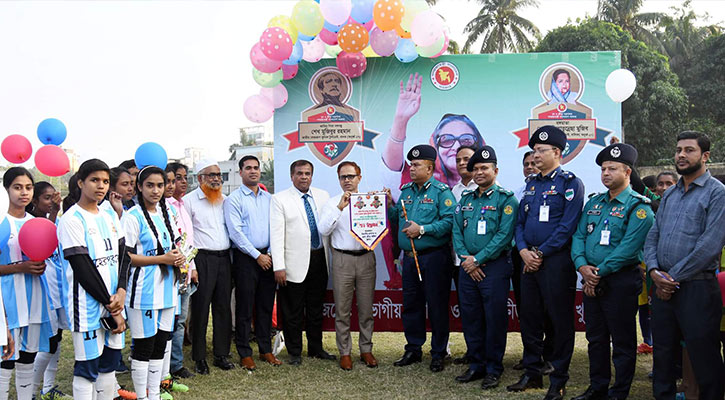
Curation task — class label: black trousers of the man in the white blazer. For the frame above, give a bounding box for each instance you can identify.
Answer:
[279,249,327,356]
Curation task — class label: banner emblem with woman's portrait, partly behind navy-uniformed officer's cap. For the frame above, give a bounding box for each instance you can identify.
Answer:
[512,63,612,164]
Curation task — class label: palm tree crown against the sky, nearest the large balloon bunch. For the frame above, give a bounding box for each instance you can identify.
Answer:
[462,0,541,53]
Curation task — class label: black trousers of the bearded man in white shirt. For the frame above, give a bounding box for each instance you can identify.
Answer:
[191,250,232,361]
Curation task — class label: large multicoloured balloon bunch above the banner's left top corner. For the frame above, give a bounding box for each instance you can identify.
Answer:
[244,0,449,123]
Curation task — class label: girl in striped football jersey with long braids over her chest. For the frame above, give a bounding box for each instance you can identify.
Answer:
[121,166,185,400]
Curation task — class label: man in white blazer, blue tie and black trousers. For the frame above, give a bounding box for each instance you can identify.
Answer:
[269,160,335,365]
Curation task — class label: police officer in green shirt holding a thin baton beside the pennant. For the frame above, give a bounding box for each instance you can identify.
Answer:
[386,145,455,372]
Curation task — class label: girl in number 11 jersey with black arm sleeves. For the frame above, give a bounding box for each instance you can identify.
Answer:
[58,159,130,400]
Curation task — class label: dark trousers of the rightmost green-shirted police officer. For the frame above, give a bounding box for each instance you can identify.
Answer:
[584,265,642,399]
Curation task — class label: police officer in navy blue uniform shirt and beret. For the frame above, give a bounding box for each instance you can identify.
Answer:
[506,125,584,400]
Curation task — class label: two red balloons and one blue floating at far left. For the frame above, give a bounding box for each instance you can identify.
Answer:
[0,118,70,176]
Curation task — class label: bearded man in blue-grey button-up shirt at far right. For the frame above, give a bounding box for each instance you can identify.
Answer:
[644,131,725,400]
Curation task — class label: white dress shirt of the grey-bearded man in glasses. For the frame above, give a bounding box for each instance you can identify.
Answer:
[183,188,230,251]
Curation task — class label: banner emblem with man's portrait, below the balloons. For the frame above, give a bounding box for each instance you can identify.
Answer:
[282,67,380,167]
